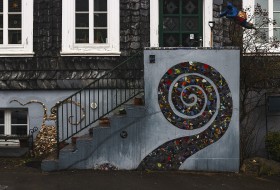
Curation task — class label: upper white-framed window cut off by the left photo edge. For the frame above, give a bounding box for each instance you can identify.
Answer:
[0,0,33,57]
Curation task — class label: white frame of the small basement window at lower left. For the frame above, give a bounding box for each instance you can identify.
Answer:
[0,108,29,135]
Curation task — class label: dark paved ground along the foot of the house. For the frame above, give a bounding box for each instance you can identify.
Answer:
[0,159,280,190]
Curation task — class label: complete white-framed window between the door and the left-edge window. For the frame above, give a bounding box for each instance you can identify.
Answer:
[61,0,120,56]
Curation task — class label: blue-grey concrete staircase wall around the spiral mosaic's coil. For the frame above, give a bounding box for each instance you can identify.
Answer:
[50,49,239,171]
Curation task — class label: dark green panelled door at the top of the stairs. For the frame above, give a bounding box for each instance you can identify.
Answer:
[159,0,203,47]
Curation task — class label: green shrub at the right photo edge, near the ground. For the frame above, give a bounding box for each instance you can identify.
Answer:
[265,132,280,161]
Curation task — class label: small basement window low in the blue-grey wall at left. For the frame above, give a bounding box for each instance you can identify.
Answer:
[0,109,28,135]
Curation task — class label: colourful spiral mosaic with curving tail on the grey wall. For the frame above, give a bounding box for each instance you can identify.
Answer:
[138,62,232,170]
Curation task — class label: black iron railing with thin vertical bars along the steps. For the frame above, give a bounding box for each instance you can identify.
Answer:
[54,52,144,155]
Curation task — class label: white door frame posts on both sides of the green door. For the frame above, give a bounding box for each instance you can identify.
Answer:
[150,0,213,47]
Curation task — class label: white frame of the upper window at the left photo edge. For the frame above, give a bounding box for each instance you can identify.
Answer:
[0,0,34,57]
